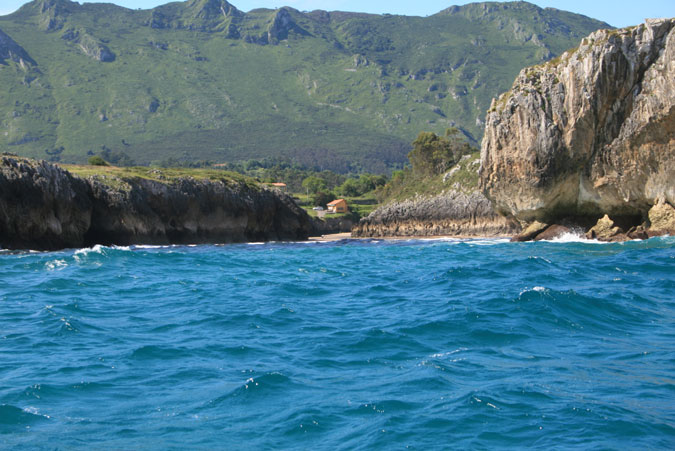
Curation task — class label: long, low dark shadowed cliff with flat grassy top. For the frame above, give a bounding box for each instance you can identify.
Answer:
[0,156,312,249]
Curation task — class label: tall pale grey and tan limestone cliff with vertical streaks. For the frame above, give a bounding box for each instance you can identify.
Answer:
[480,19,675,222]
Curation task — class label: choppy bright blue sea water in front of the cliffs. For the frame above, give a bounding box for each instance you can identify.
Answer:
[0,238,675,449]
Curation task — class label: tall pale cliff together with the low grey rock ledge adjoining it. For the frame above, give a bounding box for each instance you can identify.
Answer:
[353,19,675,241]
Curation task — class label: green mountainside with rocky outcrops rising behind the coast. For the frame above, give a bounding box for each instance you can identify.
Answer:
[0,0,609,171]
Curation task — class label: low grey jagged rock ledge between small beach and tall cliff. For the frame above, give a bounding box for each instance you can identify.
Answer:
[352,190,520,237]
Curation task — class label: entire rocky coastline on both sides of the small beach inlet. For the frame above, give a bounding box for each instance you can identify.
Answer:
[0,19,675,249]
